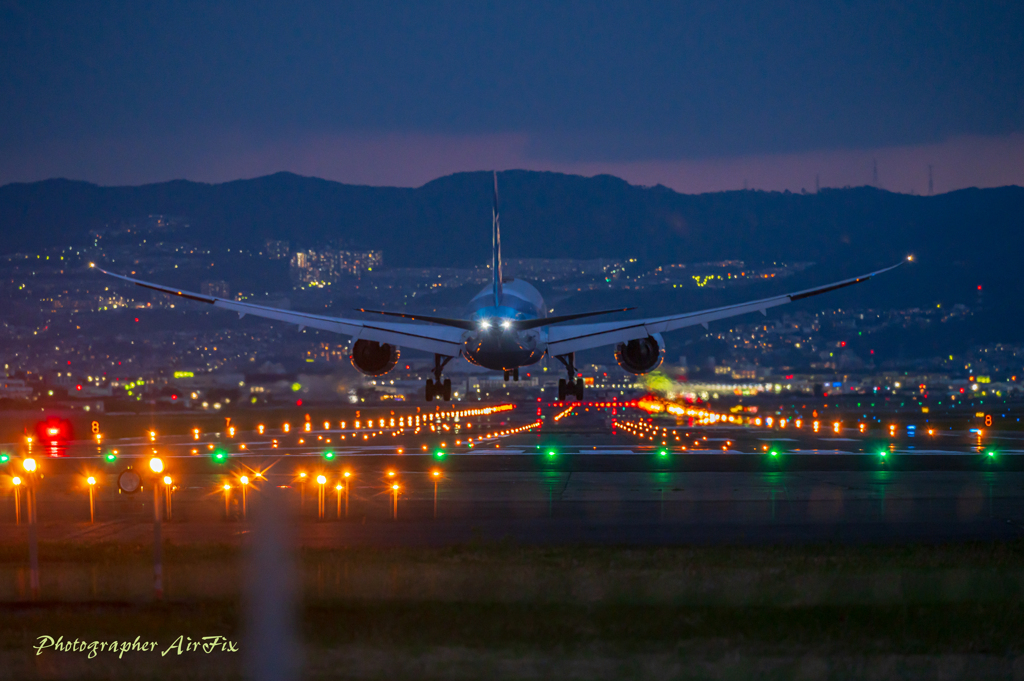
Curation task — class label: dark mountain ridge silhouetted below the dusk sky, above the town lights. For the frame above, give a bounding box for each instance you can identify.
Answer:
[0,171,1024,331]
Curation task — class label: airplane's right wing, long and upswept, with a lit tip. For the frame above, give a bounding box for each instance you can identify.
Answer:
[548,258,909,355]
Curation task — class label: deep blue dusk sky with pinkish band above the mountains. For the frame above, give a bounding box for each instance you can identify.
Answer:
[0,0,1024,194]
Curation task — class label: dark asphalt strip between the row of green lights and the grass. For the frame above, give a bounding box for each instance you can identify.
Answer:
[4,468,1024,547]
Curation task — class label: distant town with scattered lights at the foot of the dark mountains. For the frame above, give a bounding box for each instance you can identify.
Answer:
[0,215,1024,411]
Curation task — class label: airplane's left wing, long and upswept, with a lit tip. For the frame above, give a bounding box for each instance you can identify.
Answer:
[93,265,463,357]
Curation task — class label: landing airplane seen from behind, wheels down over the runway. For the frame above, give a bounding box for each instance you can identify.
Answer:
[96,172,912,401]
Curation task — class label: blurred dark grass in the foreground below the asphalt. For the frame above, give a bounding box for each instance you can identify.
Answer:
[0,543,1024,679]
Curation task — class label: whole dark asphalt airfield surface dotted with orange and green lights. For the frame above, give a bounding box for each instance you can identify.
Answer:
[0,407,1024,547]
